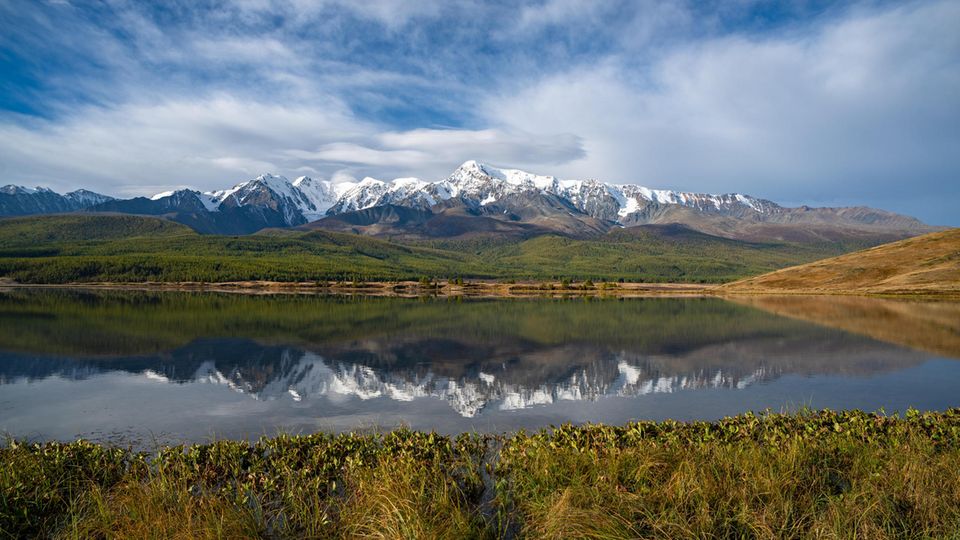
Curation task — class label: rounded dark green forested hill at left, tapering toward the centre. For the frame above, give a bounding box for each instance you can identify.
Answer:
[0,215,481,283]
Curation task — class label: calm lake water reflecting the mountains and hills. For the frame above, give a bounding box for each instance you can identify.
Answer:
[0,289,960,444]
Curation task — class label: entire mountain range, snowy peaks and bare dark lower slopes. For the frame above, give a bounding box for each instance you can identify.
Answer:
[0,161,935,241]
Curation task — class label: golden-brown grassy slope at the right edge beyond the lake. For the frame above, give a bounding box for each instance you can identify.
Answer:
[721,228,960,296]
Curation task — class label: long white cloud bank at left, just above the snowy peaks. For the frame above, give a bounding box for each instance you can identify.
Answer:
[0,95,581,196]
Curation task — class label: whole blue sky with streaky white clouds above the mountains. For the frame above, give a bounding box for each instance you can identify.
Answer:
[0,0,960,226]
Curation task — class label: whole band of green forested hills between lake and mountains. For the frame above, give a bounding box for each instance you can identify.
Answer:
[0,215,884,283]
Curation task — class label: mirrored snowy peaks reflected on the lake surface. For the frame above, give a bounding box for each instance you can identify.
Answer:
[193,350,773,418]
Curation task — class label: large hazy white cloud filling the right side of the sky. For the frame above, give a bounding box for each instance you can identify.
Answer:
[485,1,960,223]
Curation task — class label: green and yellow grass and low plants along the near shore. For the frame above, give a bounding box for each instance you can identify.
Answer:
[0,409,960,538]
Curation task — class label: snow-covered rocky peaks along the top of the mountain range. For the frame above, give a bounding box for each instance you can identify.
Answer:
[122,161,779,226]
